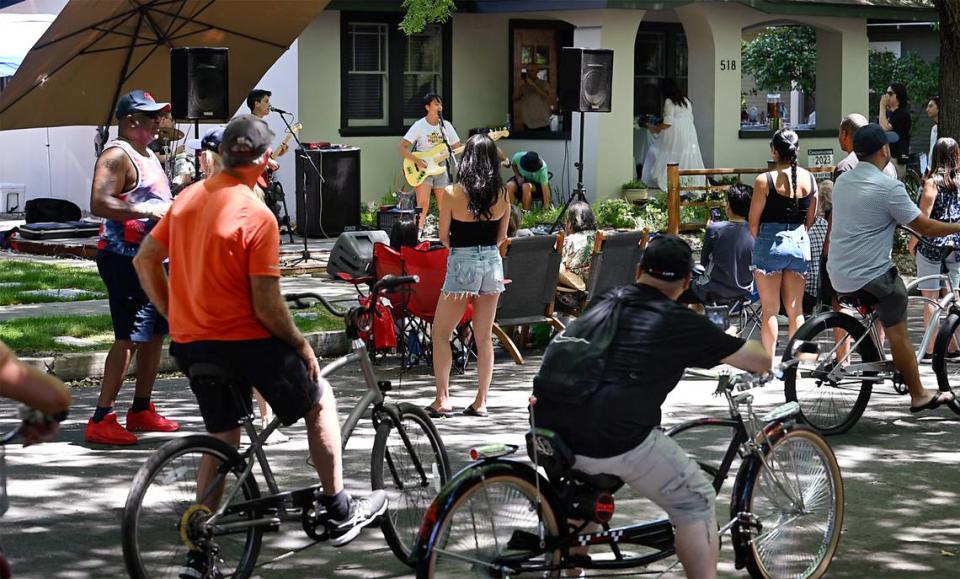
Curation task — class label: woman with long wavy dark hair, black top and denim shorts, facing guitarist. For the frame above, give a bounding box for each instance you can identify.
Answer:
[426,135,510,417]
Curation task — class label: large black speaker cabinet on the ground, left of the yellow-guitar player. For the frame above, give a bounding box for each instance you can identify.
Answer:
[297,147,360,237]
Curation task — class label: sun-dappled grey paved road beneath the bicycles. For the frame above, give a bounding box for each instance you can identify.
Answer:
[0,348,960,578]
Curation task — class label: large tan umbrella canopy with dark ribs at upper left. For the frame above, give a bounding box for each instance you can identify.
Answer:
[0,0,329,130]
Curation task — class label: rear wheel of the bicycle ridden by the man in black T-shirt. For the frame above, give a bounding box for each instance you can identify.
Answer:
[417,474,560,578]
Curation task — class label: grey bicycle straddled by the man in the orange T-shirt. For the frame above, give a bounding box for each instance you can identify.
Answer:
[122,276,450,578]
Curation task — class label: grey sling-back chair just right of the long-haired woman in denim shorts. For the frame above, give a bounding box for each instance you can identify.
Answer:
[493,234,564,364]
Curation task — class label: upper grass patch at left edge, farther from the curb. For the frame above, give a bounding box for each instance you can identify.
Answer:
[0,259,107,306]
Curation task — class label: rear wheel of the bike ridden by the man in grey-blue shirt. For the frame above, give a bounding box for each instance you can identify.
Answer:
[783,312,880,434]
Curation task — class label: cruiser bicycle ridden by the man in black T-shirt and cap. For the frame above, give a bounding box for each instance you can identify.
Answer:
[416,374,844,579]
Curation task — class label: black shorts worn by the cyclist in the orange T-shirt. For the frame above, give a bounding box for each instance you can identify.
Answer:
[170,338,322,433]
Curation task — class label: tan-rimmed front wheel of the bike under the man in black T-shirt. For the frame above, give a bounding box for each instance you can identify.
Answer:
[746,429,844,578]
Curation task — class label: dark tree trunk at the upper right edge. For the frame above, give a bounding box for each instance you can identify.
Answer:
[933,0,960,139]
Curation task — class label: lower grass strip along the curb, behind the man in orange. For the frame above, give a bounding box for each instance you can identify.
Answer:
[0,308,343,356]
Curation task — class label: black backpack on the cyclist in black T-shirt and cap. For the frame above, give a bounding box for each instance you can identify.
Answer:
[533,286,636,404]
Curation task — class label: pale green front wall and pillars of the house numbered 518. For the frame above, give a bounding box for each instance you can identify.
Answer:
[299,3,867,202]
